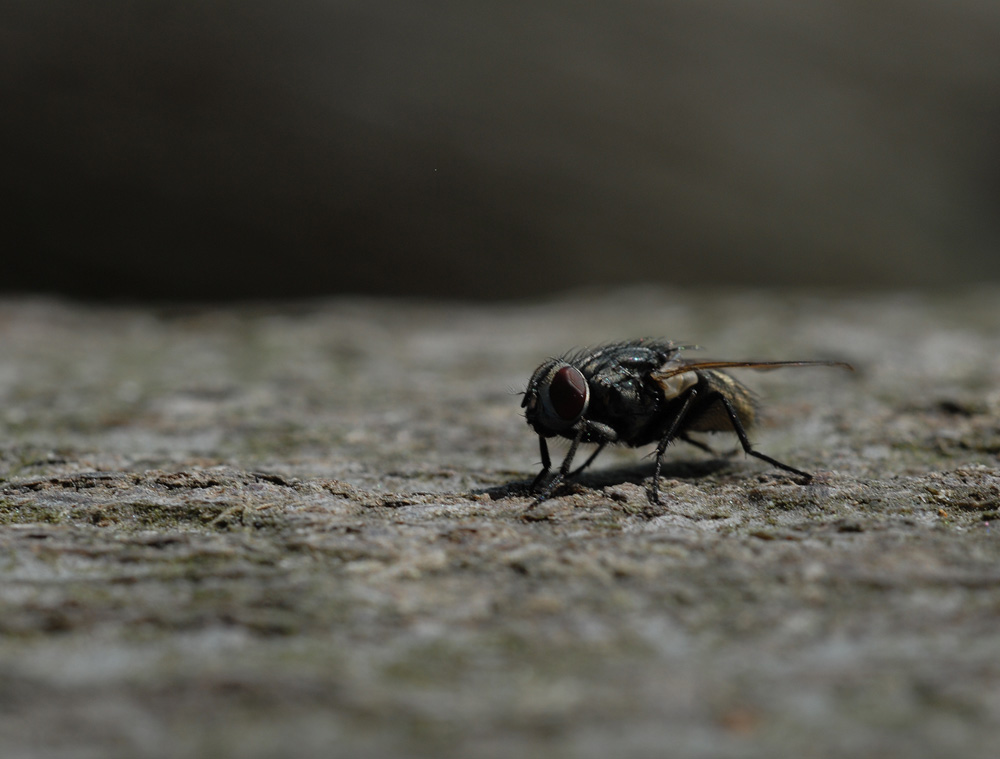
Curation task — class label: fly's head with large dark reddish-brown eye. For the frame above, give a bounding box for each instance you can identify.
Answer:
[521,359,590,437]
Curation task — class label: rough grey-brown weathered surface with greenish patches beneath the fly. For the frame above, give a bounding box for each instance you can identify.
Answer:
[0,289,1000,757]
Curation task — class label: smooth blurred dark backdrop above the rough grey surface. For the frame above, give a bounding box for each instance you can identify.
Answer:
[0,0,1000,300]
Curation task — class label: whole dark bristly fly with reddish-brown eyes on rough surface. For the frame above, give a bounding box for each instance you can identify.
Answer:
[521,338,853,503]
